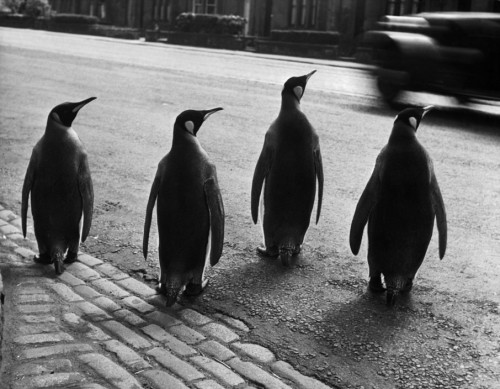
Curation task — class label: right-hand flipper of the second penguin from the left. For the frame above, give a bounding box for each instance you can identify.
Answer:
[203,177,224,266]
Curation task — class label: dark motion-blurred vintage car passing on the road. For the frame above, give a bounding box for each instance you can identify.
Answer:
[365,12,500,103]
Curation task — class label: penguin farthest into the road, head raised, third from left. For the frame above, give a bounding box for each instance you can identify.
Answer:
[251,70,324,266]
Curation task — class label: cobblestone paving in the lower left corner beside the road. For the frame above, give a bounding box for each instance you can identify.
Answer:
[0,205,336,389]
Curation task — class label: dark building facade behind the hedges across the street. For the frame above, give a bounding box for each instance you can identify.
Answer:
[50,0,500,36]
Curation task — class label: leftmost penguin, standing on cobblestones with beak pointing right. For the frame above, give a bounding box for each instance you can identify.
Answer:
[21,97,96,274]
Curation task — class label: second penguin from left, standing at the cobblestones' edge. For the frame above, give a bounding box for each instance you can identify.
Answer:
[143,108,224,307]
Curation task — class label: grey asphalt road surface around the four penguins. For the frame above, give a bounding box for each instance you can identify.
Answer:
[0,28,500,388]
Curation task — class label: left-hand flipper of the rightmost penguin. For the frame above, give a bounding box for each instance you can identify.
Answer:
[349,153,382,255]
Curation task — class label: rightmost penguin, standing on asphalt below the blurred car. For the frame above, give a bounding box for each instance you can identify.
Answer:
[349,106,447,306]
